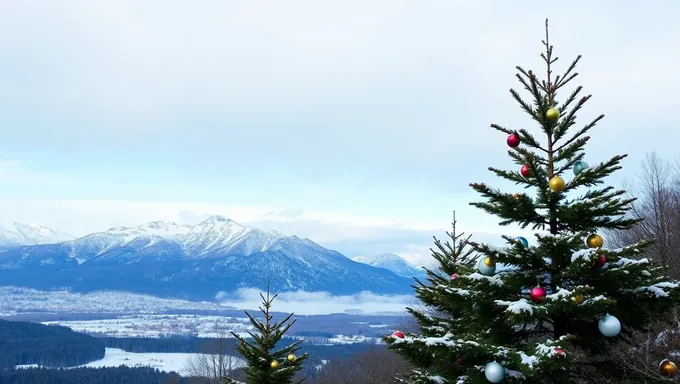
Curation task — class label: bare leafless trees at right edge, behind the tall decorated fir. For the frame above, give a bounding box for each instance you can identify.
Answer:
[607,153,680,278]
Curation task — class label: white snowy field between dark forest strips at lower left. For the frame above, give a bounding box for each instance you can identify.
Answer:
[17,348,245,376]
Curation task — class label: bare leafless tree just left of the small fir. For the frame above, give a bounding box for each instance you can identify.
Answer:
[186,336,243,384]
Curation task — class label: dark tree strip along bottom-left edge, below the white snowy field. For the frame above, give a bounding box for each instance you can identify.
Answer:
[0,366,187,384]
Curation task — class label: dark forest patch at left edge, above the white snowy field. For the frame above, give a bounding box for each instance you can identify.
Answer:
[0,320,105,369]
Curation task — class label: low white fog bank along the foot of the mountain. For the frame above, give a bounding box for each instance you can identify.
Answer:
[217,288,415,315]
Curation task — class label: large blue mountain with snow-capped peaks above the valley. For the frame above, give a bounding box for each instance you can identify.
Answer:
[0,216,412,300]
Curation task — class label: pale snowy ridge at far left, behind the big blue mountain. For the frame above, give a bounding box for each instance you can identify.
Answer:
[0,222,73,248]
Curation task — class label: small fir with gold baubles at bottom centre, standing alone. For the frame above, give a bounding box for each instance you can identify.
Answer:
[224,288,308,384]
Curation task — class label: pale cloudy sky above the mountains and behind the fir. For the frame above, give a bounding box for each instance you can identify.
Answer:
[0,0,680,268]
